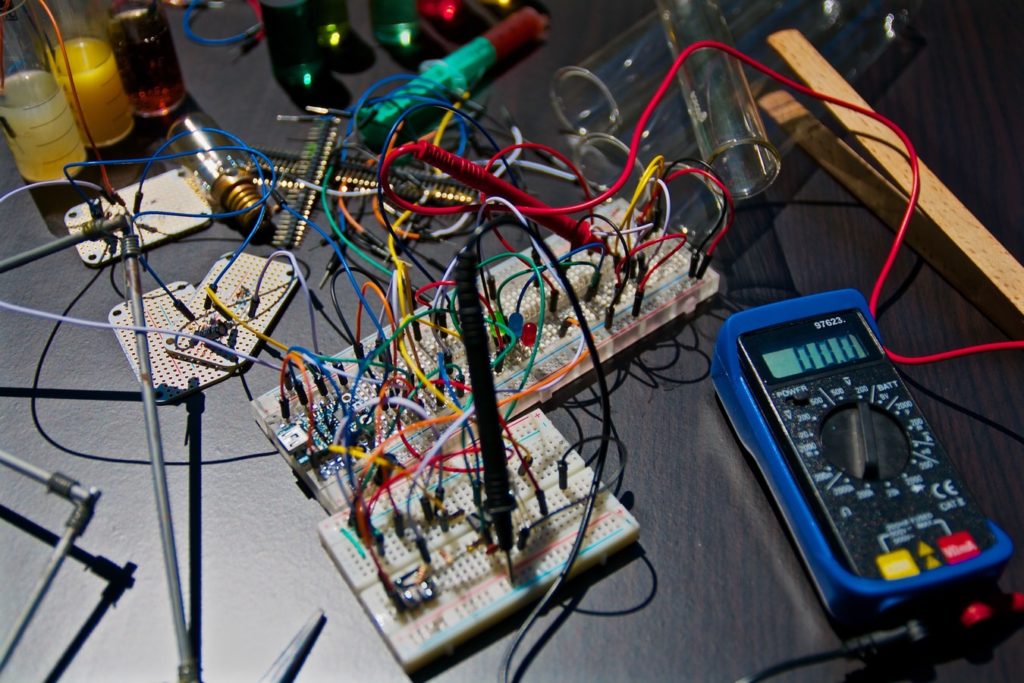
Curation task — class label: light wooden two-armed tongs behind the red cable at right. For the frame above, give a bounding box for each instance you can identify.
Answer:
[759,30,1024,339]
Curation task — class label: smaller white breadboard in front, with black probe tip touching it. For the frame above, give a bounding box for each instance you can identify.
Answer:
[319,410,640,672]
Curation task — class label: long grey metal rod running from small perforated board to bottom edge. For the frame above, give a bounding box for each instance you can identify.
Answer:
[121,233,199,681]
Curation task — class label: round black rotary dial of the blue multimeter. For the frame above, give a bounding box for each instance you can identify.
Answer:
[820,400,910,481]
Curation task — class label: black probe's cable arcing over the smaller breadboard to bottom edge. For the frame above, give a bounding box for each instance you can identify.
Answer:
[466,216,611,683]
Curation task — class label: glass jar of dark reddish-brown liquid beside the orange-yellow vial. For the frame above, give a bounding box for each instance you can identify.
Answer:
[109,0,185,117]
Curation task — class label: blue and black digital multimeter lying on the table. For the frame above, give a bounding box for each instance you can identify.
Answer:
[712,290,1013,624]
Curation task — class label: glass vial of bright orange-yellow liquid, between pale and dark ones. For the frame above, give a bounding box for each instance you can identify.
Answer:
[47,0,135,147]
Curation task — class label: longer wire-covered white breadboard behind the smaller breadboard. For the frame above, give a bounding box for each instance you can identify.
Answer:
[251,236,719,513]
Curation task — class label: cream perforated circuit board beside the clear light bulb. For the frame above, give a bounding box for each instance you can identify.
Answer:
[65,169,212,268]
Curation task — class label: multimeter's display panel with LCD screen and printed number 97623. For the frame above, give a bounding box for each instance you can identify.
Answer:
[742,310,881,381]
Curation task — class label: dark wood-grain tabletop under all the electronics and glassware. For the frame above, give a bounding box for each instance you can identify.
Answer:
[0,0,1024,681]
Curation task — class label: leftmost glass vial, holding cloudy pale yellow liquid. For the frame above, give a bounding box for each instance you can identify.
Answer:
[0,0,85,182]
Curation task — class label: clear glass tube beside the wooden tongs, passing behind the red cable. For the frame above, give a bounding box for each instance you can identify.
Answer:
[656,0,779,199]
